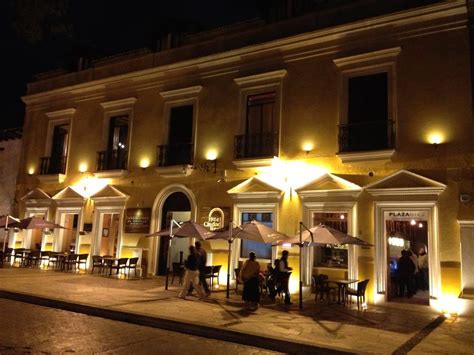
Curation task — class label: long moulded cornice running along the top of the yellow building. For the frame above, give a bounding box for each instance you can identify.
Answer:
[22,0,467,106]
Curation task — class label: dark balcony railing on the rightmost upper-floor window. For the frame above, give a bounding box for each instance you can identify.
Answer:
[339,120,395,153]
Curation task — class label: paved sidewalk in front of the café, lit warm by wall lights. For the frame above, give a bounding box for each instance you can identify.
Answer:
[0,268,474,354]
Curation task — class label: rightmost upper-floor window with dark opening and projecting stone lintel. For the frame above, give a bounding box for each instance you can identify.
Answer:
[334,48,400,159]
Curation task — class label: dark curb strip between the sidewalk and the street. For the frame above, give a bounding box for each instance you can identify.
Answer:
[0,290,353,354]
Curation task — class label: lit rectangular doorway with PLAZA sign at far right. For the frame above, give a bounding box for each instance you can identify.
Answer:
[384,211,430,305]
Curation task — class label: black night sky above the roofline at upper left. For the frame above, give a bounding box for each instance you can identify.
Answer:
[0,0,259,129]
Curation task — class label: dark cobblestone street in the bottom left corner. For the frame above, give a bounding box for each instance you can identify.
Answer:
[0,299,273,355]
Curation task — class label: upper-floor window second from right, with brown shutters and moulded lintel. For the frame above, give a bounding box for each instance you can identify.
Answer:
[234,70,286,163]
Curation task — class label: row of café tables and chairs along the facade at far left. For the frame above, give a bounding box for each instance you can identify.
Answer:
[0,248,141,279]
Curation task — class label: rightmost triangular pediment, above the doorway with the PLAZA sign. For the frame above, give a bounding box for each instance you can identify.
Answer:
[364,170,446,196]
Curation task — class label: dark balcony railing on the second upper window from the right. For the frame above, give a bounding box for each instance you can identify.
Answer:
[234,132,279,159]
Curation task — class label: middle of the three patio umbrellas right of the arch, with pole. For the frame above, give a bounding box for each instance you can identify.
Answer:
[209,221,289,298]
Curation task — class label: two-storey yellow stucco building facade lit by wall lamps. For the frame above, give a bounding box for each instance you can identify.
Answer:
[11,0,474,316]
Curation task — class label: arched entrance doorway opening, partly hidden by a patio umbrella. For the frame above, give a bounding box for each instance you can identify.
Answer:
[157,192,191,275]
